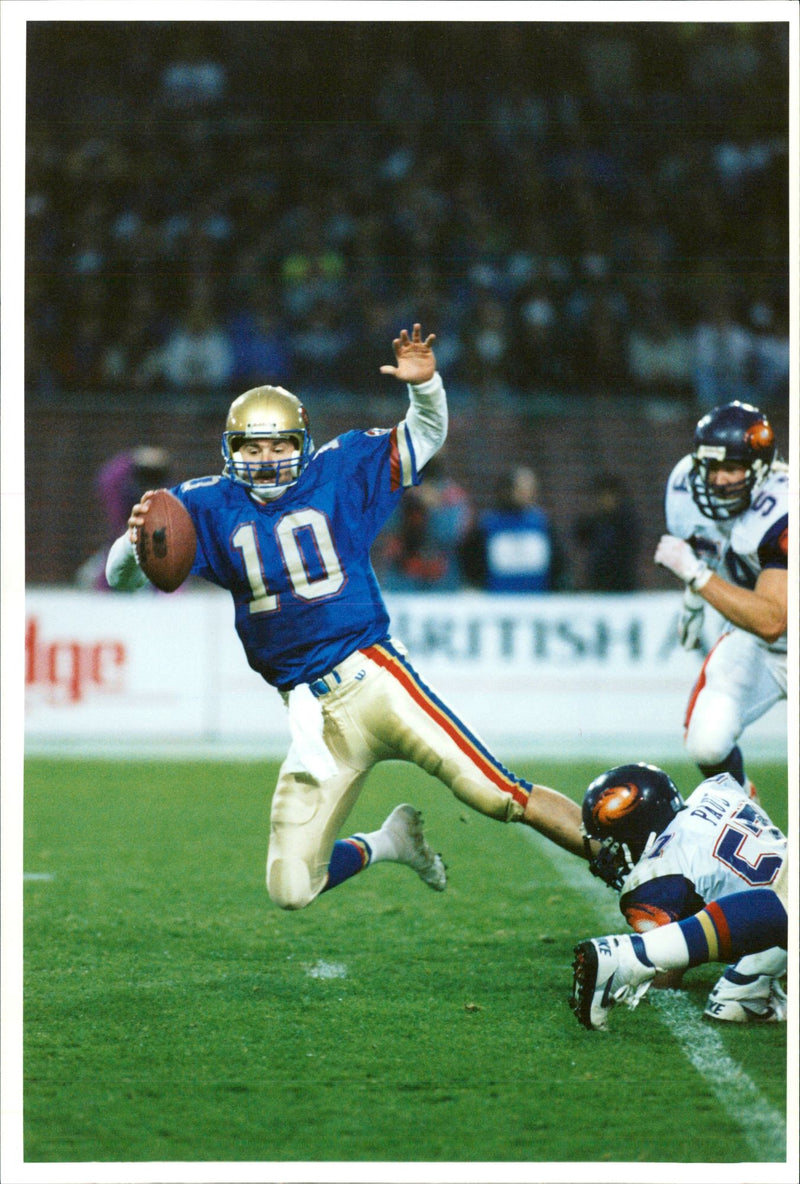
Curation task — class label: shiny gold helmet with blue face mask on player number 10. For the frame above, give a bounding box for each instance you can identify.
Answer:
[222,386,314,497]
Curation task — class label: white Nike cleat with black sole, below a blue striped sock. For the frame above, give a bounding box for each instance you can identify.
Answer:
[569,934,656,1031]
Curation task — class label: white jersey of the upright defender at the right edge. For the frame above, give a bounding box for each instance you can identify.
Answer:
[664,455,789,652]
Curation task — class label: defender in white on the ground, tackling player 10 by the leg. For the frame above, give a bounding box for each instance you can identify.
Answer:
[582,764,787,1023]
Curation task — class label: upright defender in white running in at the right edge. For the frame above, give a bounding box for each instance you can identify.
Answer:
[654,403,788,792]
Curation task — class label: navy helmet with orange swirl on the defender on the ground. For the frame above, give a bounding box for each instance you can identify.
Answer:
[581,764,684,890]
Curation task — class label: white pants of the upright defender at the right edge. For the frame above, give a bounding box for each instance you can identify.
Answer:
[685,629,786,765]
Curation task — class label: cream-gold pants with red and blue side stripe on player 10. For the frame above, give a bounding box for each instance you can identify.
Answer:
[266,642,530,908]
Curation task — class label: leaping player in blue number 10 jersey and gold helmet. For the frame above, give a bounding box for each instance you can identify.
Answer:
[107,324,585,909]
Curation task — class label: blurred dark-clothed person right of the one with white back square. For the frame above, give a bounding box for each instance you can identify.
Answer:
[573,472,640,592]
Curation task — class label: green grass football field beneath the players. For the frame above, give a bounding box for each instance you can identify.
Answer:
[24,759,787,1163]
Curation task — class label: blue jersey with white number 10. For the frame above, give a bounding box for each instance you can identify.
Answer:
[172,423,419,690]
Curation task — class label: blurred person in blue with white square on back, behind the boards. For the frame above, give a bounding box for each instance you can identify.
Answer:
[462,465,564,592]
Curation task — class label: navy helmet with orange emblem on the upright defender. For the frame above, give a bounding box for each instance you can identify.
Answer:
[689,401,775,522]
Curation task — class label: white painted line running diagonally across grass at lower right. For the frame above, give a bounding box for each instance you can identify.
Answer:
[521,828,787,1162]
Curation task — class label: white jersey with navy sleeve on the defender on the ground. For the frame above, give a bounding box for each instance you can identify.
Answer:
[620,773,786,929]
